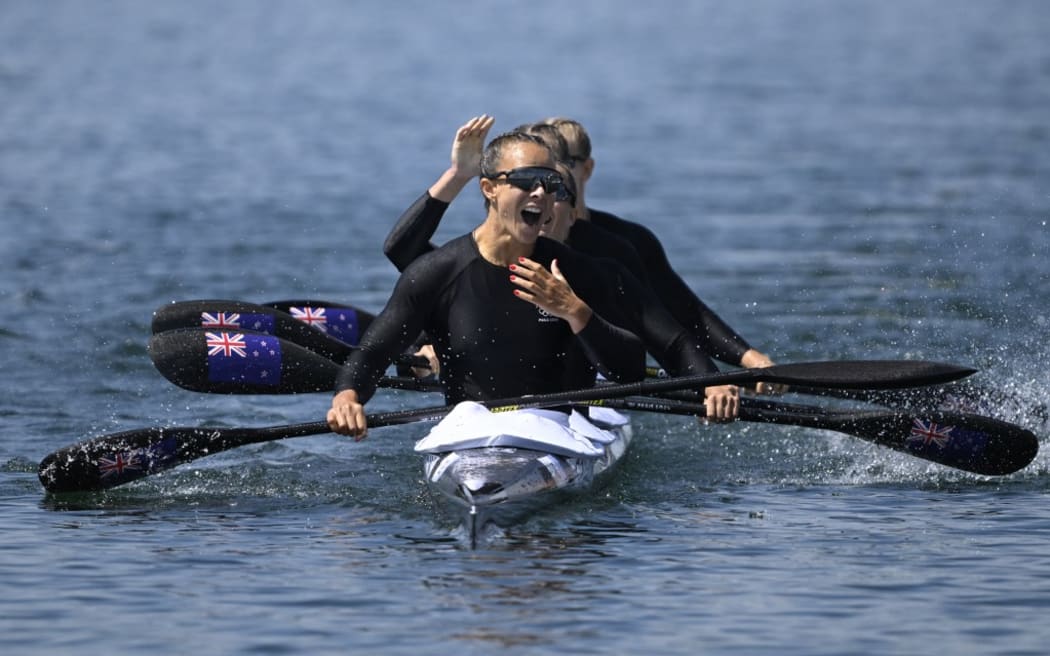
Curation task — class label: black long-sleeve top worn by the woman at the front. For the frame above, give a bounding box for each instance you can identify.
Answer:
[336,234,645,403]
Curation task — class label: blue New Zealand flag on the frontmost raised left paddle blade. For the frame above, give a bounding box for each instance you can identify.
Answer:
[205,333,280,385]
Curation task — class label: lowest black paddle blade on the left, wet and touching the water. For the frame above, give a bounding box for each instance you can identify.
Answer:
[38,422,329,492]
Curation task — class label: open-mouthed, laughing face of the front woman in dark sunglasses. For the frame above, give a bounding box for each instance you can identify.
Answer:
[481,140,554,244]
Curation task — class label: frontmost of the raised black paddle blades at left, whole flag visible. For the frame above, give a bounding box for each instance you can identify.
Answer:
[149,329,339,394]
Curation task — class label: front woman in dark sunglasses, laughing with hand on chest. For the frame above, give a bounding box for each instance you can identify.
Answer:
[328,132,645,439]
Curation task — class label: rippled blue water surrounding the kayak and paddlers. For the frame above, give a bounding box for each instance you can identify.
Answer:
[0,0,1050,654]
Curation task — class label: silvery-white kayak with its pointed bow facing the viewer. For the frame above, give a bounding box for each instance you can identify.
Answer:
[415,401,632,547]
